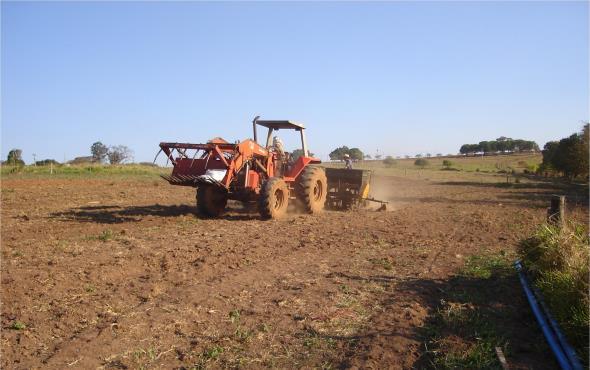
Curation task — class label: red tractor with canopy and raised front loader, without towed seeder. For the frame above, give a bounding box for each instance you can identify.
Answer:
[158,117,328,219]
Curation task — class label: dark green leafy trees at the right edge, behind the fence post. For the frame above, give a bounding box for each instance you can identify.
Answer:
[539,123,590,180]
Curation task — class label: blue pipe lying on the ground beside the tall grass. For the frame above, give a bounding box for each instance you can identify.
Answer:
[514,261,582,370]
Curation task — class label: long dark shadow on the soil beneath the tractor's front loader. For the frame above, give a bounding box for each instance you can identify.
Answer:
[49,204,260,224]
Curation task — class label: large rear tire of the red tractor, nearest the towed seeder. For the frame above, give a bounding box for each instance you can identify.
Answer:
[297,166,328,213]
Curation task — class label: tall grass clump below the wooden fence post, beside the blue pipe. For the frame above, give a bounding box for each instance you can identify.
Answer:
[519,222,590,366]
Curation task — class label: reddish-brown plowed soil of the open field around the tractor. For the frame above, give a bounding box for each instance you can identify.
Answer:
[1,176,588,369]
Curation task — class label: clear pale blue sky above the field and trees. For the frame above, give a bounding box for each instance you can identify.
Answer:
[1,1,589,162]
